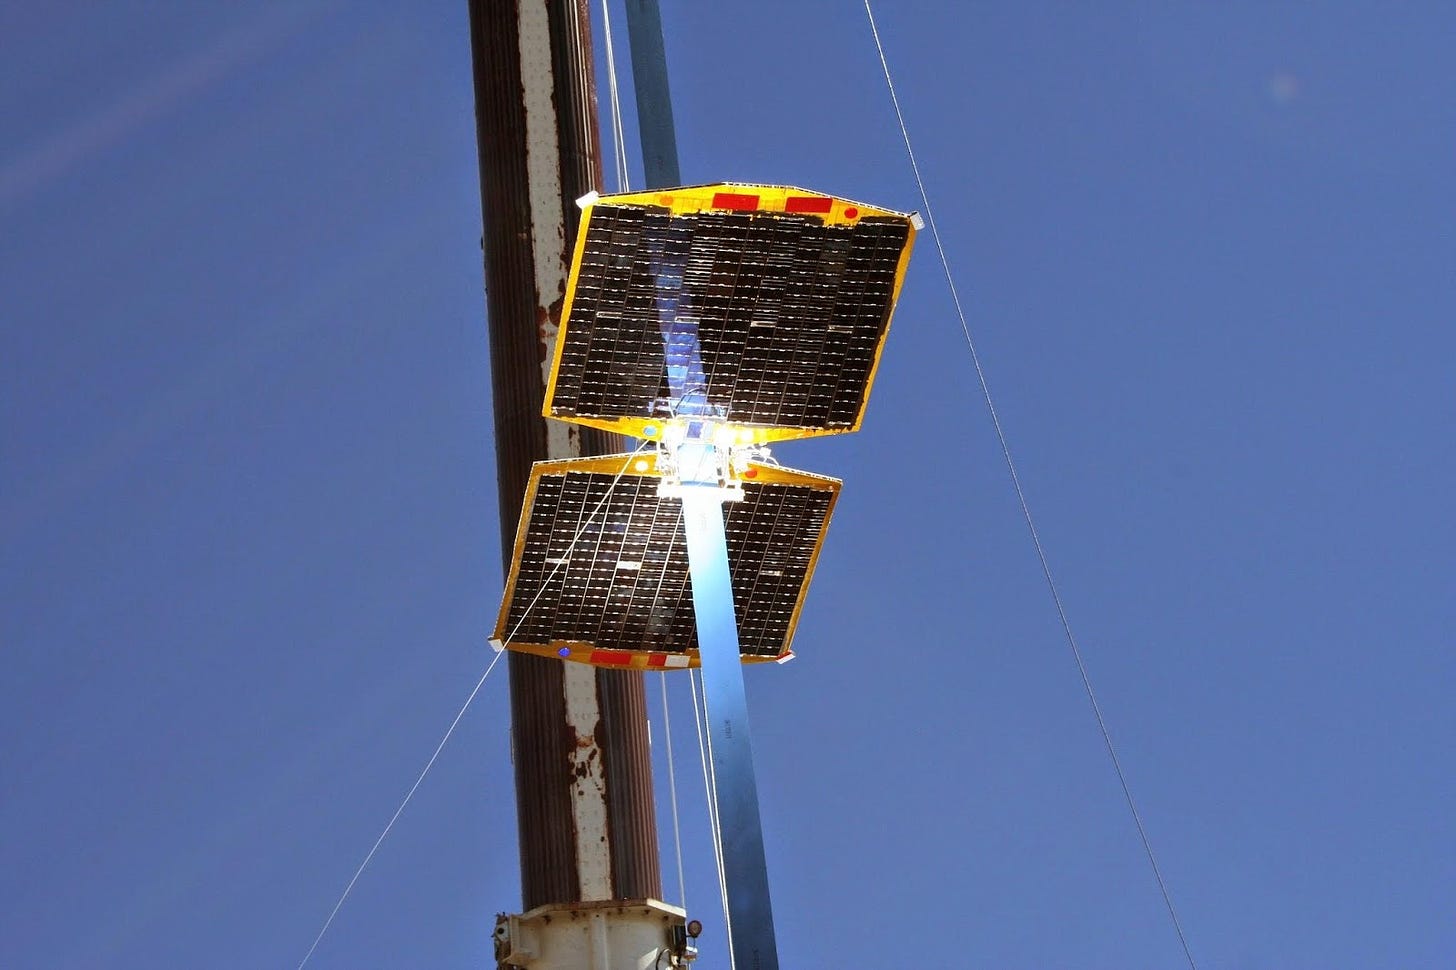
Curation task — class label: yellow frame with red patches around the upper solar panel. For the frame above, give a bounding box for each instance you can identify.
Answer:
[542,182,920,444]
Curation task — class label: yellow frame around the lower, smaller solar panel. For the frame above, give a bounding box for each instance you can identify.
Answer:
[492,452,842,670]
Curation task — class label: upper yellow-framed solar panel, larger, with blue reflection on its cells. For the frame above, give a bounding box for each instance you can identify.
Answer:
[545,185,916,443]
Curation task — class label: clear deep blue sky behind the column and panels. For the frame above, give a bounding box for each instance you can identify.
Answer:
[0,0,1456,970]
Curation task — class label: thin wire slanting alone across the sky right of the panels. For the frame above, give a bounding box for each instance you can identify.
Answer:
[865,0,1198,970]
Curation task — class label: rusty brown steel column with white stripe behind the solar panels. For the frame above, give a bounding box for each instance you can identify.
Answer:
[470,0,661,910]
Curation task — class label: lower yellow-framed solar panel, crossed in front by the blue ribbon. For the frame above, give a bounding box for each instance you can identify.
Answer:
[495,454,840,669]
